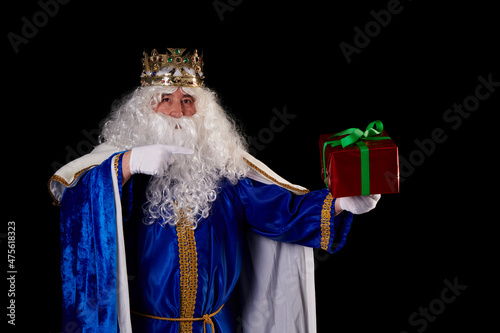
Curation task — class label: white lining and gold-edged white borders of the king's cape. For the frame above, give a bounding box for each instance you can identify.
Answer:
[48,144,316,333]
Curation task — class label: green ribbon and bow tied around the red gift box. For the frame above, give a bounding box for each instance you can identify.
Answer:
[323,120,390,195]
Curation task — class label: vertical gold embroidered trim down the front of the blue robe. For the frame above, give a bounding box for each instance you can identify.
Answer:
[176,212,198,333]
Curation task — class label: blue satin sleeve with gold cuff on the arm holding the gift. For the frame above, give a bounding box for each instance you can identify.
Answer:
[235,178,352,253]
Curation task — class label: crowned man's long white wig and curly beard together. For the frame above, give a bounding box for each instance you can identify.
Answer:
[100,87,248,228]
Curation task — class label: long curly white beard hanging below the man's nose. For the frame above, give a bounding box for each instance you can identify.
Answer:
[144,114,224,228]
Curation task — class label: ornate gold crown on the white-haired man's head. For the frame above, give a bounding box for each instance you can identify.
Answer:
[141,48,205,87]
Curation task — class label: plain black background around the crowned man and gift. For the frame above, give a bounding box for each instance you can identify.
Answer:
[0,0,500,333]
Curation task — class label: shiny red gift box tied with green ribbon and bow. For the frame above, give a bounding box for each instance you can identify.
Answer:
[319,121,399,198]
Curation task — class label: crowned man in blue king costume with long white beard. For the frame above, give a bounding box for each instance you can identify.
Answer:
[49,49,380,333]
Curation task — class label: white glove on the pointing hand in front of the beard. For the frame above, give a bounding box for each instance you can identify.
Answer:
[130,145,194,176]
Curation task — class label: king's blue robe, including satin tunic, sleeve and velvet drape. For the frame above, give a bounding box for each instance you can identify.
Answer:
[61,154,352,333]
